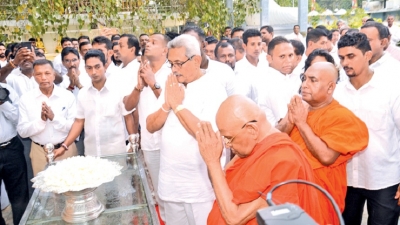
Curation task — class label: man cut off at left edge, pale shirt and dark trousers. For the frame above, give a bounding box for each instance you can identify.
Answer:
[0,83,29,224]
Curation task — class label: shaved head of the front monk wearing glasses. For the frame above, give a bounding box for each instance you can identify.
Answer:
[217,95,272,158]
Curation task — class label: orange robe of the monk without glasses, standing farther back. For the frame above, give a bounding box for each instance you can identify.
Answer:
[290,100,369,225]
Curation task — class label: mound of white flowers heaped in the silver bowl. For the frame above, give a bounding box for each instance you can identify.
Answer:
[32,156,122,194]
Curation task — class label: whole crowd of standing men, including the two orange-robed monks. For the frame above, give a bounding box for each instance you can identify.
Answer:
[0,16,400,225]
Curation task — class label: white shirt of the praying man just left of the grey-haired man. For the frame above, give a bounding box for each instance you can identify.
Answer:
[137,63,171,151]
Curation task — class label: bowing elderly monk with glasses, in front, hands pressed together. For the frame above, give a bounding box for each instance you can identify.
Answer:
[196,95,321,225]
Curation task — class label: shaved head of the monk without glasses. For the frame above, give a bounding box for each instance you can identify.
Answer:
[301,62,338,108]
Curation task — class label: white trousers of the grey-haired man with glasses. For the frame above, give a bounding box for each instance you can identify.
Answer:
[164,201,214,225]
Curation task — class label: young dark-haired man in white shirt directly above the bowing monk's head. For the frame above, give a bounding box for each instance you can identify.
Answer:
[235,29,268,103]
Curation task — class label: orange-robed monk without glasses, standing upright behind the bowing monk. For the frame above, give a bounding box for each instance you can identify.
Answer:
[285,62,369,224]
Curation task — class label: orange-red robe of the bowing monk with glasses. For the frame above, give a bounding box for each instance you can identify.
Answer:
[207,133,321,225]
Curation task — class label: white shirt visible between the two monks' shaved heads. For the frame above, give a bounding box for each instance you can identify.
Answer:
[258,67,301,126]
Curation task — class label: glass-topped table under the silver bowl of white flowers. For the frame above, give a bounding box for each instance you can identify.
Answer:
[20,153,159,225]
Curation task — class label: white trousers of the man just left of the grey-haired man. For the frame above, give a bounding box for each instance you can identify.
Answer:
[142,149,165,221]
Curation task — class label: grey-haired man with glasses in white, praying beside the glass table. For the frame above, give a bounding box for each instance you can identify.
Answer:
[147,34,227,225]
